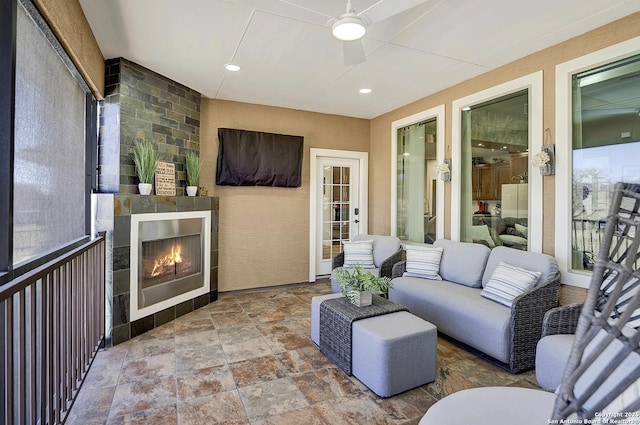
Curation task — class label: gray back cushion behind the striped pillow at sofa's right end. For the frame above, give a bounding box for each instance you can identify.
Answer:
[482,246,558,287]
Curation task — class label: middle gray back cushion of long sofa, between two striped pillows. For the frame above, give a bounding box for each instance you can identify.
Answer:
[433,239,490,288]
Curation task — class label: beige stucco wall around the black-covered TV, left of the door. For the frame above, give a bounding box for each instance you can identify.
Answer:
[200,99,369,292]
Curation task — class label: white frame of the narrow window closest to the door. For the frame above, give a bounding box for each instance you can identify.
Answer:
[389,104,445,239]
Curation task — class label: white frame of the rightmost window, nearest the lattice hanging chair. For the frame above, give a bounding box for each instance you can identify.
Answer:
[555,37,640,288]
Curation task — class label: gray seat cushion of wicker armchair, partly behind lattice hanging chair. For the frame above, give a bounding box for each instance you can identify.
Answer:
[536,334,576,391]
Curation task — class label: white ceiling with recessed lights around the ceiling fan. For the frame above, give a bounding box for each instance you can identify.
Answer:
[80,0,640,118]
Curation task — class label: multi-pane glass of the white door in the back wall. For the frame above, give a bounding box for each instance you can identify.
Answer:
[322,166,351,260]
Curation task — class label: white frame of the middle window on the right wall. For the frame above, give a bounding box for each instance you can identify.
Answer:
[451,71,543,252]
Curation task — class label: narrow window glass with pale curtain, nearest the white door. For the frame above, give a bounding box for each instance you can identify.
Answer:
[396,119,438,243]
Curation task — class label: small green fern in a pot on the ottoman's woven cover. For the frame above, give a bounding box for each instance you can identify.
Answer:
[333,264,393,307]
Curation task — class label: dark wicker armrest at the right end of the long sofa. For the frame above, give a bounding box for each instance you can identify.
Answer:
[509,273,560,373]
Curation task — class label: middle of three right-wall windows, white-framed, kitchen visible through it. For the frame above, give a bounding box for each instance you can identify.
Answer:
[451,71,543,252]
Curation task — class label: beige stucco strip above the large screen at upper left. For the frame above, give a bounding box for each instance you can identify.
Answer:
[34,0,104,99]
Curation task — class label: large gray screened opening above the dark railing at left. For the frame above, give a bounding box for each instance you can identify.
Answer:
[0,1,97,283]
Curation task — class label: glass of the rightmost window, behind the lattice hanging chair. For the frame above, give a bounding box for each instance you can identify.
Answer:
[571,56,640,270]
